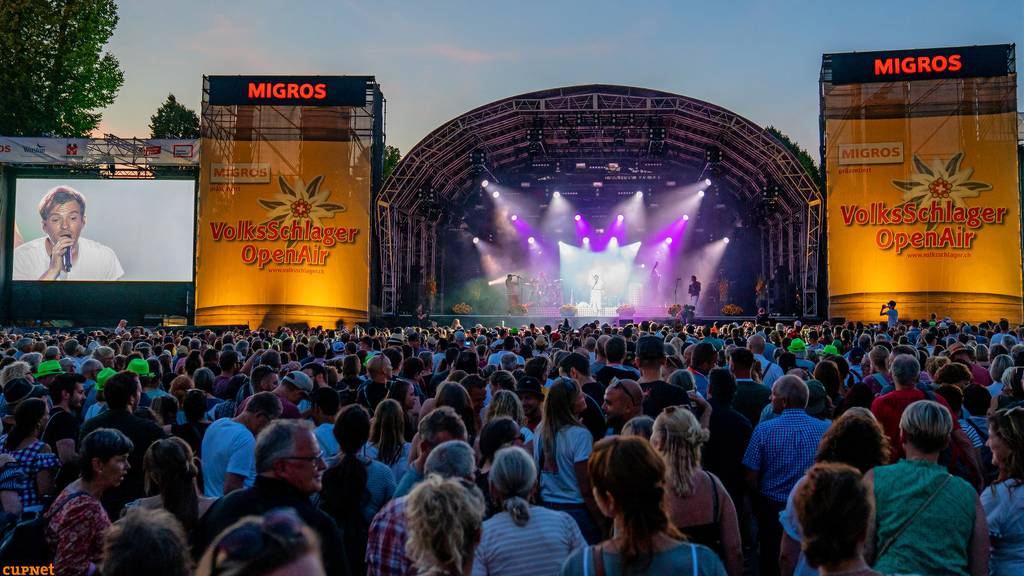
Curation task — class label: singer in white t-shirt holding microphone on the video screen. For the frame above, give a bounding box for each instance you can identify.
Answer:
[13,186,125,280]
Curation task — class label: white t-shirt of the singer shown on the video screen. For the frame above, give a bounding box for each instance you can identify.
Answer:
[12,236,125,280]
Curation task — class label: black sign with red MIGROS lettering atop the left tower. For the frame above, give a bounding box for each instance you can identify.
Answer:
[207,76,373,107]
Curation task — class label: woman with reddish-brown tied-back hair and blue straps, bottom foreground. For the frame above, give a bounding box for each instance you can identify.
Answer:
[561,436,726,576]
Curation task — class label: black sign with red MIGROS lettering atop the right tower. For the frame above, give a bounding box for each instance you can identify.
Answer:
[828,44,1013,84]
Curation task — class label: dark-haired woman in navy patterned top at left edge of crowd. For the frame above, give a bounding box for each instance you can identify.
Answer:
[0,393,60,513]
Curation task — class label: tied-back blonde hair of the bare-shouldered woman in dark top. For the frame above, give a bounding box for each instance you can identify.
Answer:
[651,406,710,497]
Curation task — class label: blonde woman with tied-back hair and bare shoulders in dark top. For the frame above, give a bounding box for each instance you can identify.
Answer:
[650,406,743,576]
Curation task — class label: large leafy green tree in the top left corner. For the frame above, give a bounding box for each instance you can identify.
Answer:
[0,0,124,136]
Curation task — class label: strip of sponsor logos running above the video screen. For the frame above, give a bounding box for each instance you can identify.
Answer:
[0,136,199,166]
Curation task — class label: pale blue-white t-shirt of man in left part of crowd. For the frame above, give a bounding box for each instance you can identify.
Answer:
[203,418,256,498]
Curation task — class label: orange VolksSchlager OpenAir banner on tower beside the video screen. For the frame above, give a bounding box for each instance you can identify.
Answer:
[196,140,370,327]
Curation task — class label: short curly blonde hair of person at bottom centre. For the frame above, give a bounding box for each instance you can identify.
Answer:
[406,475,483,576]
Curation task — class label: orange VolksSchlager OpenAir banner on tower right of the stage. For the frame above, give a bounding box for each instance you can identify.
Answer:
[825,109,1021,322]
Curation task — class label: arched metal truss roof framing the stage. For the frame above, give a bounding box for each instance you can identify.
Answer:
[375,85,824,318]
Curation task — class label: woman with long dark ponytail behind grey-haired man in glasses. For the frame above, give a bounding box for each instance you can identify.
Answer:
[319,401,396,574]
